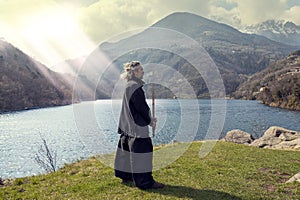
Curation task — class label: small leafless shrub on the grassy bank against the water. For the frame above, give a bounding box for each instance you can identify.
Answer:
[35,138,57,172]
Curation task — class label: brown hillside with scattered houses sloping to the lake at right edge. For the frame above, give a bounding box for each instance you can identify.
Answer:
[234,50,300,110]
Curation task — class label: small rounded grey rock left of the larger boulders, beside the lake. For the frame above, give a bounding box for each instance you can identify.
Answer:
[224,129,253,144]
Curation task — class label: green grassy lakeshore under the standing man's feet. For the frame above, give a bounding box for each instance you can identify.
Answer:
[0,141,300,200]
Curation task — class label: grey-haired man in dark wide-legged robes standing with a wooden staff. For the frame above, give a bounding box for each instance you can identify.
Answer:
[115,61,164,189]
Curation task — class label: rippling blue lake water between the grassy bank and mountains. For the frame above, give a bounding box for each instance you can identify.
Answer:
[0,99,300,178]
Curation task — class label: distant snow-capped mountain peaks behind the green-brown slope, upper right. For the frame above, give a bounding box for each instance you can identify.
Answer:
[243,20,300,46]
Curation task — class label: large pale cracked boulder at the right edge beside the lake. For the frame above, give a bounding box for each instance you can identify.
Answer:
[251,126,300,150]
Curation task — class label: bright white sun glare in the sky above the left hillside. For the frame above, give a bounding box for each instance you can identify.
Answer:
[21,5,95,67]
